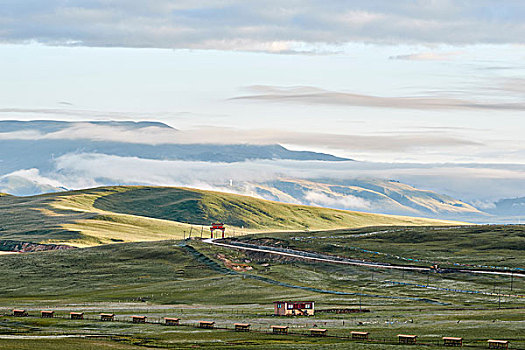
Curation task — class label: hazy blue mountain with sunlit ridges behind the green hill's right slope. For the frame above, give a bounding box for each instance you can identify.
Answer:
[238,179,488,219]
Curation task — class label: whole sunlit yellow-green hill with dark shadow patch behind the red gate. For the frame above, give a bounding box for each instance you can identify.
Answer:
[0,186,466,246]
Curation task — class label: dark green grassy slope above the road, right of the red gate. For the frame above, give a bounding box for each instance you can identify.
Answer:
[239,225,525,268]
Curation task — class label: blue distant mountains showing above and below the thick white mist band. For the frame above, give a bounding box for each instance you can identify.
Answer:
[0,120,525,222]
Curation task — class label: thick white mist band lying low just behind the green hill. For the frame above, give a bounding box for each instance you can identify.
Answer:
[50,154,525,204]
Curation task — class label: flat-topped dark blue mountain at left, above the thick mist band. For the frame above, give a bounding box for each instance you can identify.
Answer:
[0,120,348,175]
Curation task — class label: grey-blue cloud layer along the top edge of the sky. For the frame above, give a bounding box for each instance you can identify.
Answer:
[0,0,525,53]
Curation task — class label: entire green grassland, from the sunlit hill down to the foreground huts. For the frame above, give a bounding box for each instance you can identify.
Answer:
[0,187,525,350]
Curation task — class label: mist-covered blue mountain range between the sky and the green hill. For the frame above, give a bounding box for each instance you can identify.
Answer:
[0,120,523,222]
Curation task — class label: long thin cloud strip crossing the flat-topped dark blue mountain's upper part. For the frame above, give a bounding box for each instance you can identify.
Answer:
[0,123,481,152]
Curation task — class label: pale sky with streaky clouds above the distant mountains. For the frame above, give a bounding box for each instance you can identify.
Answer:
[0,0,525,205]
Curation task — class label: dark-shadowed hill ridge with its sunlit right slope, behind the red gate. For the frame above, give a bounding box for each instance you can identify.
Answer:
[93,187,464,230]
